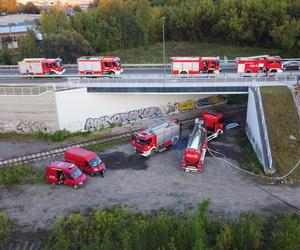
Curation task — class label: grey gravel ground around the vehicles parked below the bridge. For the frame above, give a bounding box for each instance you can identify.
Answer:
[0,130,300,232]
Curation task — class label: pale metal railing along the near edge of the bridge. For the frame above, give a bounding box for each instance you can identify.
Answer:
[0,75,297,95]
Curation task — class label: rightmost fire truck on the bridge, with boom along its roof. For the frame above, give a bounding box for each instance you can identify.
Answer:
[236,55,282,73]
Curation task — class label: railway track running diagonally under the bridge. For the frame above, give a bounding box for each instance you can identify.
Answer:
[0,106,246,168]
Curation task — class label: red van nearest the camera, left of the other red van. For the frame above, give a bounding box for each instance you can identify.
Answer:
[46,161,87,189]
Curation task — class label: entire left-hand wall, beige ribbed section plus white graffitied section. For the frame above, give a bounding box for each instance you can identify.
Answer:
[0,88,225,133]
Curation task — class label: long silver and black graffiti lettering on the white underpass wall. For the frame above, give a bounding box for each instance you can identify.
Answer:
[85,107,163,130]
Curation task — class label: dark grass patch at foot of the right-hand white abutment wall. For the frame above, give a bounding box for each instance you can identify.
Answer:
[237,133,263,174]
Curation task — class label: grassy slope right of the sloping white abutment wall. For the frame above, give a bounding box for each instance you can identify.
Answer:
[261,86,300,180]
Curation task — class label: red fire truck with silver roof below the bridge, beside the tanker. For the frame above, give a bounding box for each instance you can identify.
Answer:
[131,121,180,157]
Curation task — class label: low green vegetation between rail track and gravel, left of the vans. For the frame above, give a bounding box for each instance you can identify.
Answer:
[0,165,46,186]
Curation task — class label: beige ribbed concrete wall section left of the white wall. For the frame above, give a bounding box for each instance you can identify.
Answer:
[0,91,59,133]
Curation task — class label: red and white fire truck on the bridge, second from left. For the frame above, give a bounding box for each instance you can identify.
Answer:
[77,56,123,75]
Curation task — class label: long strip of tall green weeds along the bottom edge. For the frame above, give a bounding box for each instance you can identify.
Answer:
[46,200,300,250]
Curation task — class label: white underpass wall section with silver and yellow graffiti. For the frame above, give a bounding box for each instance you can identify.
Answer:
[55,89,218,131]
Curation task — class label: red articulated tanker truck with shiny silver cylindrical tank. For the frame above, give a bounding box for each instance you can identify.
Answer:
[181,112,224,172]
